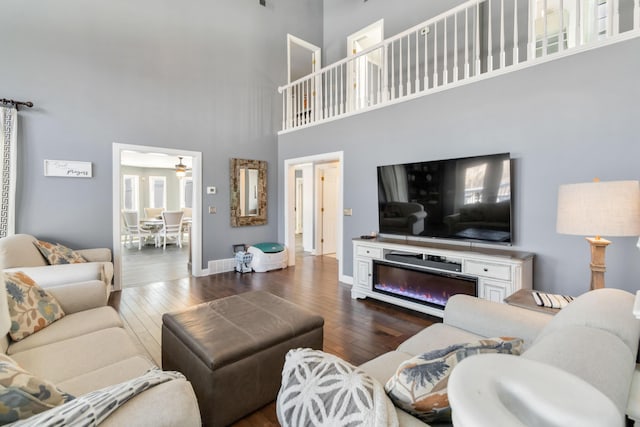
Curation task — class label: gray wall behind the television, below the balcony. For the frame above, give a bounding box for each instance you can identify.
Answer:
[278,36,640,295]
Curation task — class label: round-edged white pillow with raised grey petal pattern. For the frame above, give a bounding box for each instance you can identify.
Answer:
[276,348,398,427]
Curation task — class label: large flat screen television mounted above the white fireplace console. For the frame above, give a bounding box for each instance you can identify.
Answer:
[378,153,513,244]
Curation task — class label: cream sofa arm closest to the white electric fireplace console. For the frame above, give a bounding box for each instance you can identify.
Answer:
[443,294,553,348]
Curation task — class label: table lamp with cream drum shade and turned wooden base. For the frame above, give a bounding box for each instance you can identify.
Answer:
[556,179,640,289]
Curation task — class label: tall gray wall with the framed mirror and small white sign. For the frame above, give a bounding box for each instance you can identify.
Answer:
[0,0,322,267]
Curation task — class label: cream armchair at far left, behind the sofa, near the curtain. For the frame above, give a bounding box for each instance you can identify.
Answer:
[0,234,113,292]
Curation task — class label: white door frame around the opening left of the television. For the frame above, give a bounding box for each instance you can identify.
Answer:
[282,151,344,283]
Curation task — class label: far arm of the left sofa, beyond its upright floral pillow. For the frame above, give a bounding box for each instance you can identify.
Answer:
[47,280,109,314]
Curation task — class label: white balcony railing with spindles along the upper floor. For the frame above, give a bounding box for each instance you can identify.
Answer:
[278,0,640,131]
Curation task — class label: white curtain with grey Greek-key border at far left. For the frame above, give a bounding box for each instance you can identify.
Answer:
[0,107,18,237]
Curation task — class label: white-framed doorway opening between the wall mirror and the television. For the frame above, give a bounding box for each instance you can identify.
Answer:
[283,151,349,281]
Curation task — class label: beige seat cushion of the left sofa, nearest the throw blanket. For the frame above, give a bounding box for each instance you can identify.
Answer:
[12,328,140,384]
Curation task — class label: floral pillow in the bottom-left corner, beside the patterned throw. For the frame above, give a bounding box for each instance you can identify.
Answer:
[0,354,74,425]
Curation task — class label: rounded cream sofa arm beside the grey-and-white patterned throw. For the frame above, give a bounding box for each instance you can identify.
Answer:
[100,379,202,427]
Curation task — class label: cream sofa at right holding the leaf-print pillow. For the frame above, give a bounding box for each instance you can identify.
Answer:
[360,289,640,426]
